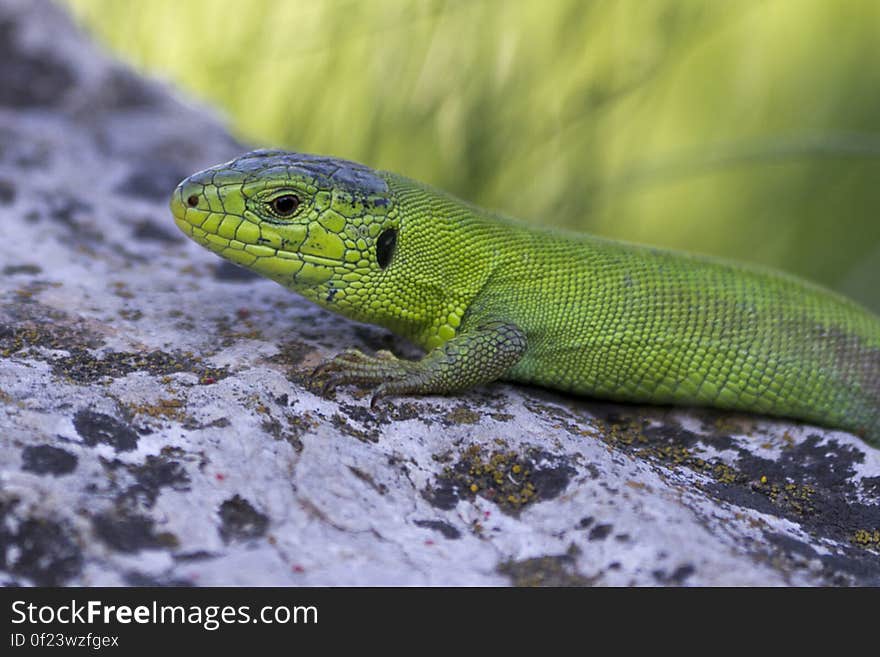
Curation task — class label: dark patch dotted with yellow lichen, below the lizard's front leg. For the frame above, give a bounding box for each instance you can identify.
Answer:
[423,444,576,513]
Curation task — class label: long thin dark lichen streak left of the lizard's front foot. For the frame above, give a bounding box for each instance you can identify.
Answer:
[50,348,229,383]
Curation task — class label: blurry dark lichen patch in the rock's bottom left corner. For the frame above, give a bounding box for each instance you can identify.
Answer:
[0,497,83,586]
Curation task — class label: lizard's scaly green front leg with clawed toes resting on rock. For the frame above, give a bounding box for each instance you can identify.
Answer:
[313,322,526,408]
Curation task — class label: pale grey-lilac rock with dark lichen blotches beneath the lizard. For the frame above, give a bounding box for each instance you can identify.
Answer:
[0,0,880,585]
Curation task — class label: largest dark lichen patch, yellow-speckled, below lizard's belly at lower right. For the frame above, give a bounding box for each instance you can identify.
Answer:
[584,413,880,584]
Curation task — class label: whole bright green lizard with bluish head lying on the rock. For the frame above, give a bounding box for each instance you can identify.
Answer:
[171,150,880,445]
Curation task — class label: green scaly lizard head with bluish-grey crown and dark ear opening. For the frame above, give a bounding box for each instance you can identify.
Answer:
[171,150,398,315]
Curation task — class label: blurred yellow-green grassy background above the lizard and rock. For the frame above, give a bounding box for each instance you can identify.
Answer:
[65,0,880,310]
